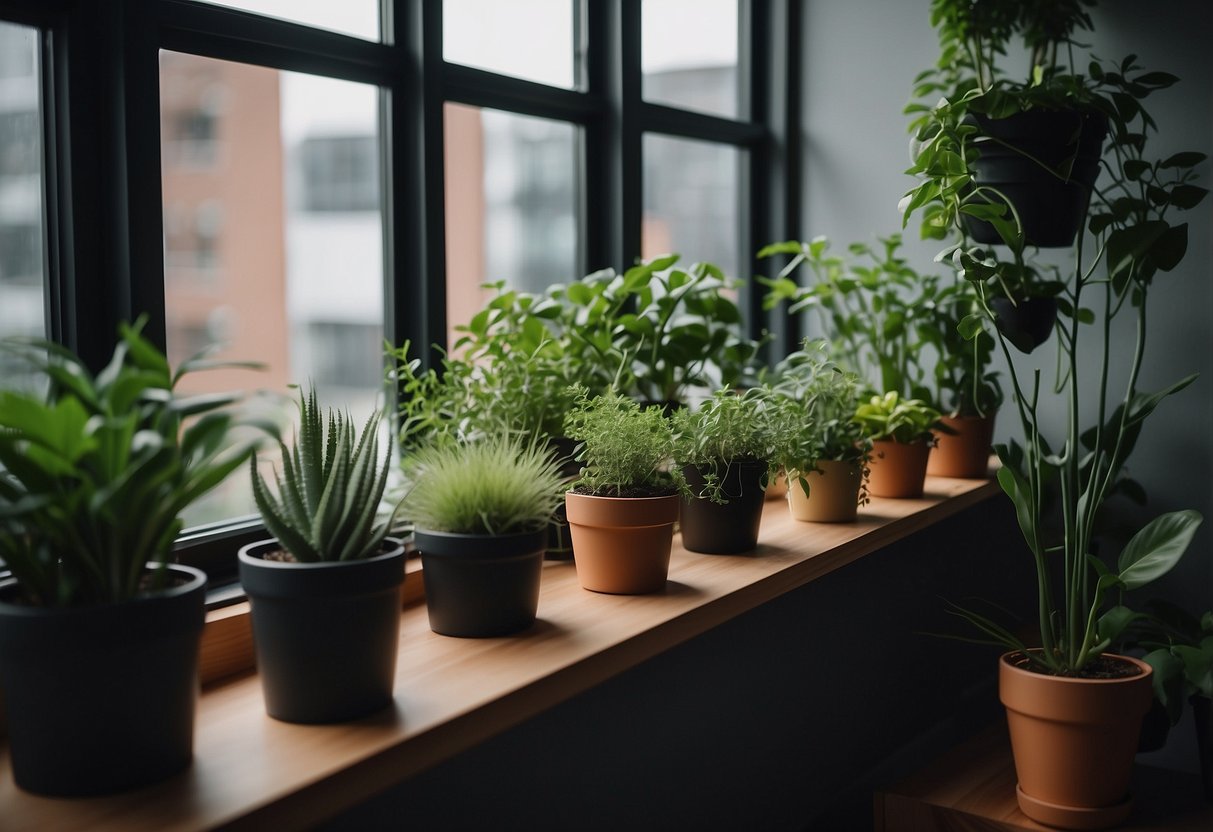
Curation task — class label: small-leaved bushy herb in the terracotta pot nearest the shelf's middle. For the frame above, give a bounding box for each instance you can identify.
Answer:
[564,389,685,497]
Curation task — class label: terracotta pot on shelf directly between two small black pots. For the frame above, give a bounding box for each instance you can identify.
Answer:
[565,491,682,595]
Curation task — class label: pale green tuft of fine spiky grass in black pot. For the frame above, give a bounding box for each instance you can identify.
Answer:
[404,434,564,535]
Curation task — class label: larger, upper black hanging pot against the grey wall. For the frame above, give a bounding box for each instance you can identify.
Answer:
[964,109,1107,247]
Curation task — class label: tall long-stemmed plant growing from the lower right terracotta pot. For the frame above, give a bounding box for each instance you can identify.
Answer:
[921,73,1206,674]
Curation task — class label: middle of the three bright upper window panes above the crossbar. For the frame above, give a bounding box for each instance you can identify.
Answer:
[443,0,577,89]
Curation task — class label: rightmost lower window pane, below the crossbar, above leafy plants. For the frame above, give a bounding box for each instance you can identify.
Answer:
[640,135,744,277]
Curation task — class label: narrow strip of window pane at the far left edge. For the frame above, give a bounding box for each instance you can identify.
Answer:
[0,22,46,387]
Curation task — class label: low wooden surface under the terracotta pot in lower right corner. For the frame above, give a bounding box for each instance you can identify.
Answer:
[875,725,1213,832]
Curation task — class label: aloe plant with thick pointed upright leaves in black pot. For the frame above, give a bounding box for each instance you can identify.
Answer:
[252,388,395,563]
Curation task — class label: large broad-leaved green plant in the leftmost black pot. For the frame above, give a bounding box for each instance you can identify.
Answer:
[0,319,252,606]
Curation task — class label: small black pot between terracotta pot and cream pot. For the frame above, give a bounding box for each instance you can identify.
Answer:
[679,462,767,554]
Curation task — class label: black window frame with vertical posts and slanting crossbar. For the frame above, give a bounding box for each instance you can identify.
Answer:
[0,0,802,599]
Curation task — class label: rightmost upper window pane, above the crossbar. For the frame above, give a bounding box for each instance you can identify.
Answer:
[640,0,738,119]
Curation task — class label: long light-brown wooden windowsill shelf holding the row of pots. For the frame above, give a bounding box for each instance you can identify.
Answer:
[0,478,1000,832]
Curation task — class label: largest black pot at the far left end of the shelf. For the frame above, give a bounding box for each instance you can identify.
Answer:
[0,566,206,797]
